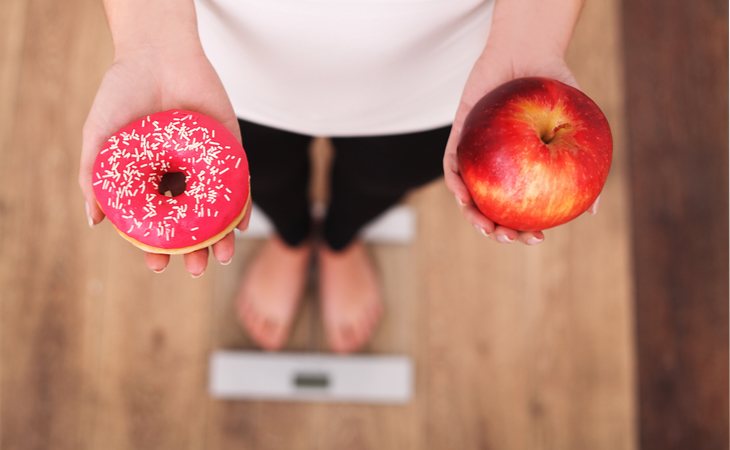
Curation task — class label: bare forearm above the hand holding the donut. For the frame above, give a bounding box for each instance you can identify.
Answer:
[104,0,199,53]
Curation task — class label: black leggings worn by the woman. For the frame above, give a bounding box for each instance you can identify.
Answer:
[238,119,451,250]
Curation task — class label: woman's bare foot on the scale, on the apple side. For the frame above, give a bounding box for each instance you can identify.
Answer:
[318,239,383,353]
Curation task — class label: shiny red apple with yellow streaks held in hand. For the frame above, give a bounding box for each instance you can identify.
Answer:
[456,77,613,231]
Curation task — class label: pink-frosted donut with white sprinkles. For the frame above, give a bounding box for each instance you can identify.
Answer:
[92,109,251,255]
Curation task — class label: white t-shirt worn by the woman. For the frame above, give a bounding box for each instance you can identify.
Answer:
[196,0,494,136]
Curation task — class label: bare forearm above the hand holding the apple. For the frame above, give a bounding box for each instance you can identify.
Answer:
[487,0,583,57]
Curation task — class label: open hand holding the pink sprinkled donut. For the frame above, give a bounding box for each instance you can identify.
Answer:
[78,5,251,277]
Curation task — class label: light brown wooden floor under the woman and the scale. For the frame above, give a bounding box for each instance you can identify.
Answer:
[0,0,637,450]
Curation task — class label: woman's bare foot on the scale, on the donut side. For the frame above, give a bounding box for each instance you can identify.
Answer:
[236,236,312,350]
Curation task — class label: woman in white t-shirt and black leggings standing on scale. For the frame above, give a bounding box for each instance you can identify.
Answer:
[79,0,595,352]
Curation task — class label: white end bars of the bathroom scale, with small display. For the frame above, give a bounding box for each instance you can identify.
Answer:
[209,205,415,404]
